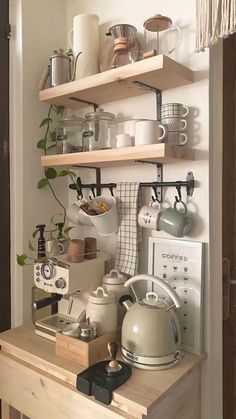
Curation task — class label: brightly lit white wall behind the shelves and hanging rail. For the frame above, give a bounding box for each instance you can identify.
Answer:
[67,0,209,260]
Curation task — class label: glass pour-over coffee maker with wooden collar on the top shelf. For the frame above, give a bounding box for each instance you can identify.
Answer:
[106,24,139,68]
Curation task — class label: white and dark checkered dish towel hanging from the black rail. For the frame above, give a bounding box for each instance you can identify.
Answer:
[116,182,142,276]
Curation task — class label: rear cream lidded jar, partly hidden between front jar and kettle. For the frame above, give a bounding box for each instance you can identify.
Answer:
[103,269,129,326]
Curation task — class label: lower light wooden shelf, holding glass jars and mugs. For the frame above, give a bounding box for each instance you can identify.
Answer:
[41,143,194,167]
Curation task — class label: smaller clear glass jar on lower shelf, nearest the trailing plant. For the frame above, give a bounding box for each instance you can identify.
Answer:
[56,117,84,154]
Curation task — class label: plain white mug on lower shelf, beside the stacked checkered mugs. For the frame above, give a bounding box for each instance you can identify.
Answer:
[135,119,167,145]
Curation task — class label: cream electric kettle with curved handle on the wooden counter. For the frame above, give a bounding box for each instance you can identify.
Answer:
[120,275,181,369]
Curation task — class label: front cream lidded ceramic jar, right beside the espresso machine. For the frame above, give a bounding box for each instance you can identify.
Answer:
[86,287,118,336]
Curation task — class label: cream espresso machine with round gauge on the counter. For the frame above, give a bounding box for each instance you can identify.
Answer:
[33,252,110,341]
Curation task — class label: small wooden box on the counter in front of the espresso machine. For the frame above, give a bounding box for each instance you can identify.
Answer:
[56,329,120,367]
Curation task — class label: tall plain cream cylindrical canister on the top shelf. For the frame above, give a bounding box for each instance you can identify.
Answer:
[73,14,99,80]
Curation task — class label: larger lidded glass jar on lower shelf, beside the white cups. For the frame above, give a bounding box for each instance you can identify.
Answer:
[83,108,116,151]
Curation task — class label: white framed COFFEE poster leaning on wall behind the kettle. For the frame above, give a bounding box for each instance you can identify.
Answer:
[148,237,203,355]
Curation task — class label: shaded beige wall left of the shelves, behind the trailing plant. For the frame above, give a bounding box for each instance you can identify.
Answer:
[10,0,67,326]
